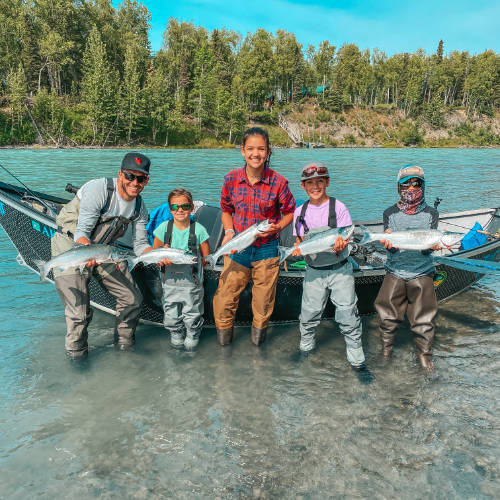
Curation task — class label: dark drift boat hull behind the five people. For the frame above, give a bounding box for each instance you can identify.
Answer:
[0,184,500,325]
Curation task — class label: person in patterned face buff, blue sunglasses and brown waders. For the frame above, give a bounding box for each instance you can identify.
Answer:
[375,165,439,372]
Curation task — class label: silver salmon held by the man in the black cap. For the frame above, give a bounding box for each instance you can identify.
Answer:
[34,245,129,281]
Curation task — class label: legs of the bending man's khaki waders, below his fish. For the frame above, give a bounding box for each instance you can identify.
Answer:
[54,262,142,352]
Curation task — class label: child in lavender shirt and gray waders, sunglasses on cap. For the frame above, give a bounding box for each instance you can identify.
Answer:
[292,162,366,371]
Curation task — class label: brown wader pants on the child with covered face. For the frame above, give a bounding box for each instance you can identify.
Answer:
[375,273,438,354]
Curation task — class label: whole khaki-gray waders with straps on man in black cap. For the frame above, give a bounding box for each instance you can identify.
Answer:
[51,179,142,357]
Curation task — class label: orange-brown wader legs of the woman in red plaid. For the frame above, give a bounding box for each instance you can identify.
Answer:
[214,255,279,330]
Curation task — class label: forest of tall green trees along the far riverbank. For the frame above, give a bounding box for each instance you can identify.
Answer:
[0,0,500,146]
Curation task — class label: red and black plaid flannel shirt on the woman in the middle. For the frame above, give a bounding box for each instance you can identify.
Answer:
[220,166,295,246]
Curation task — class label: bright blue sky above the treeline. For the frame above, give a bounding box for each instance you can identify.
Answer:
[138,0,500,54]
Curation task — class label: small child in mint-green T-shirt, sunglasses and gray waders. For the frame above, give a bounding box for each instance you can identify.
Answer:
[153,188,210,349]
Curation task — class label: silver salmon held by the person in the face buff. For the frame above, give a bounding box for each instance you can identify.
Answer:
[359,226,464,250]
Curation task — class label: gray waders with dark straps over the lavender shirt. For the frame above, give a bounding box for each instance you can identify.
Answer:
[295,197,365,366]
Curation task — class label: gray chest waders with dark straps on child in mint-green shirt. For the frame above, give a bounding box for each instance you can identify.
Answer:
[162,220,204,349]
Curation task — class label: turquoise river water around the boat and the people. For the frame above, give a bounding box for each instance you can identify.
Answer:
[0,149,500,499]
